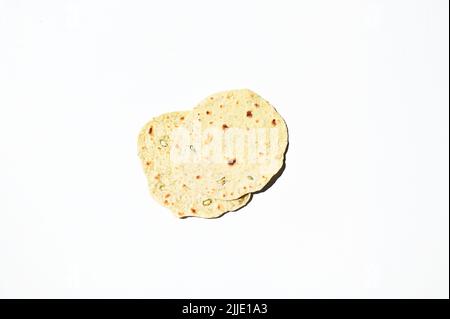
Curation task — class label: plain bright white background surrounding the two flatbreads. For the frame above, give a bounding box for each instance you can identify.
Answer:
[0,0,449,298]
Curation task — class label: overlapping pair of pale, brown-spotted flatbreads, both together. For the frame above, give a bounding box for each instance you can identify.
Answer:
[138,89,288,218]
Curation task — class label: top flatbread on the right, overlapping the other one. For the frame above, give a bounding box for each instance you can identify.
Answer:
[172,89,288,200]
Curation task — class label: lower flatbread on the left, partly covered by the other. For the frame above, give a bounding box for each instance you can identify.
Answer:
[138,112,251,218]
